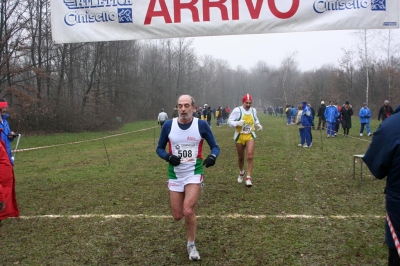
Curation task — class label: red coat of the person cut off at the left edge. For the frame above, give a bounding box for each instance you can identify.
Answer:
[0,130,19,226]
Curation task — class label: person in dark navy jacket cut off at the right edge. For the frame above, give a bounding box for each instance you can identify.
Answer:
[363,106,400,265]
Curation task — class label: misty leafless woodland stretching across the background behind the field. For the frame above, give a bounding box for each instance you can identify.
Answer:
[0,0,400,133]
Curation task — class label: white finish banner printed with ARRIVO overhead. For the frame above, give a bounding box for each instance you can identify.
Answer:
[50,0,400,43]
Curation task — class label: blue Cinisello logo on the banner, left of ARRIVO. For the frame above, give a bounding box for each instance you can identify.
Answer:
[64,0,132,26]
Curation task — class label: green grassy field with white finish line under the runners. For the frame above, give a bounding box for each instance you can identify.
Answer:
[0,114,387,265]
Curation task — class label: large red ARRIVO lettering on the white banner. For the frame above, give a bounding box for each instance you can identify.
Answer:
[144,0,300,25]
